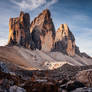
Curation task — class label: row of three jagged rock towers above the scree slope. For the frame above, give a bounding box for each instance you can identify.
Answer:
[8,9,90,56]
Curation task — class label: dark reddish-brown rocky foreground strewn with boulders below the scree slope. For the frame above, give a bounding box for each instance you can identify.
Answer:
[0,62,92,92]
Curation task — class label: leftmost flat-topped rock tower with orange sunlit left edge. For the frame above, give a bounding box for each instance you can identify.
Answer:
[8,12,30,48]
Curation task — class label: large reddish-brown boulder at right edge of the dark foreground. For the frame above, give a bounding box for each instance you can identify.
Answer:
[76,69,92,87]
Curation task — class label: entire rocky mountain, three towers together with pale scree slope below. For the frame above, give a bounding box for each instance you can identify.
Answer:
[5,9,92,69]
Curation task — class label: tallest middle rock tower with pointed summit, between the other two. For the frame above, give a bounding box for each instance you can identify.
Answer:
[30,9,55,51]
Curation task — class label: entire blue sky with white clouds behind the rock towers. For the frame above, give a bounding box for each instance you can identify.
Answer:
[0,0,92,56]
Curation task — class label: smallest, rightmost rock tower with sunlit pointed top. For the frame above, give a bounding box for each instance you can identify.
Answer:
[55,24,75,56]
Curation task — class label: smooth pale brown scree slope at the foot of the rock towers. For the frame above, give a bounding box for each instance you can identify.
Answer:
[0,46,92,70]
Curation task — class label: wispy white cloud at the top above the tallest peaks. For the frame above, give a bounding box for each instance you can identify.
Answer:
[10,0,58,10]
